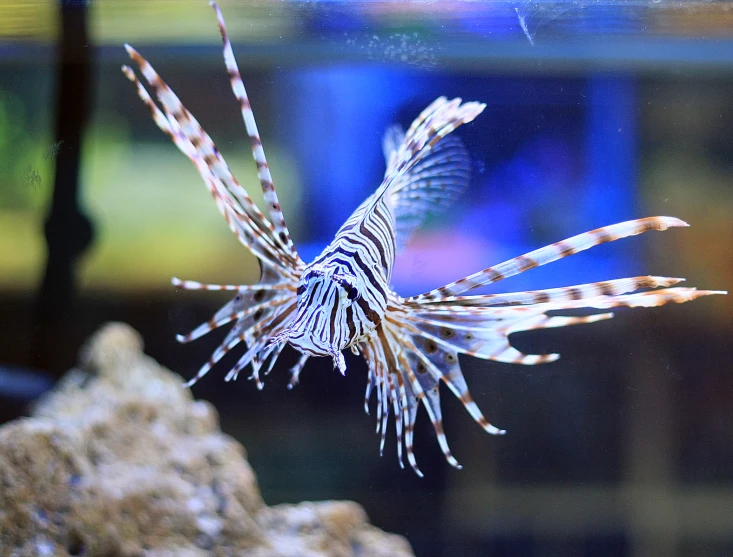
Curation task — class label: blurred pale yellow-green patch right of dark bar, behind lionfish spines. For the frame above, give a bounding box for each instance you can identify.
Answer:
[82,130,304,290]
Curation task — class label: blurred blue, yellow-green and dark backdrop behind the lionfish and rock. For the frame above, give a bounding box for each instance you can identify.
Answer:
[0,0,733,557]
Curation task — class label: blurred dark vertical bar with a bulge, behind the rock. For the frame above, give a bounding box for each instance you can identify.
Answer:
[30,0,92,371]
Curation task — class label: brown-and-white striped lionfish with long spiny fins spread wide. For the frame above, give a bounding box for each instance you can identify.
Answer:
[122,2,725,476]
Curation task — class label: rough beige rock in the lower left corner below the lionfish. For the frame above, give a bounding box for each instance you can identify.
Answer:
[0,323,412,557]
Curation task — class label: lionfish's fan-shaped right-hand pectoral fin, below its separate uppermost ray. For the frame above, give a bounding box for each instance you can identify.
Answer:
[360,260,725,475]
